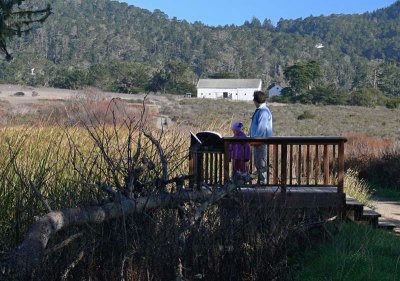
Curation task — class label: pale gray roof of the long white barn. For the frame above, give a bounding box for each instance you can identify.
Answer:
[197,79,261,89]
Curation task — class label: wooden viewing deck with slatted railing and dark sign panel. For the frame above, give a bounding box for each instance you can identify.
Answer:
[189,132,346,210]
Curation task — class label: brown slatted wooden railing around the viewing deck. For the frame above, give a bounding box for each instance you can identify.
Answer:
[190,137,346,193]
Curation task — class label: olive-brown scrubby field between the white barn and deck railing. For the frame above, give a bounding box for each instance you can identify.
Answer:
[161,99,400,139]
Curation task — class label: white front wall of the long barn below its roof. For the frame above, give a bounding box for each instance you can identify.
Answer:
[197,86,261,101]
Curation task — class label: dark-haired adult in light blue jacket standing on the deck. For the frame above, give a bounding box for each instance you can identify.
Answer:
[249,91,272,185]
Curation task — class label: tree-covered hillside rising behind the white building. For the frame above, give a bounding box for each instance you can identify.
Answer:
[0,0,400,96]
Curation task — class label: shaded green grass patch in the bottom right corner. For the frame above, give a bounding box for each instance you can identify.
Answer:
[293,223,400,281]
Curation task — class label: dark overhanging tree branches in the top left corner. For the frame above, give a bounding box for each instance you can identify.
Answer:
[0,0,51,60]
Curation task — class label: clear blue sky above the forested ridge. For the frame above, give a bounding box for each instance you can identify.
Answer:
[119,0,396,26]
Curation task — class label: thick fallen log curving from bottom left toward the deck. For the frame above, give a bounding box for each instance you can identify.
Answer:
[0,183,236,277]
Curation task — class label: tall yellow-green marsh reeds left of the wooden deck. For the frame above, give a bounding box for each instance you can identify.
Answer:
[0,124,188,248]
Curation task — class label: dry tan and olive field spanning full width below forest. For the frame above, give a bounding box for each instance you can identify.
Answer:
[0,85,400,139]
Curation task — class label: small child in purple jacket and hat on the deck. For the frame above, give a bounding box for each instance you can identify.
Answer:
[229,122,250,174]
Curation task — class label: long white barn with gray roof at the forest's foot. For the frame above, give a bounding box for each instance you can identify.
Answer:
[197,79,262,101]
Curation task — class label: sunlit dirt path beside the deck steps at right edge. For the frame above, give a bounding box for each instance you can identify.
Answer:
[371,196,400,233]
